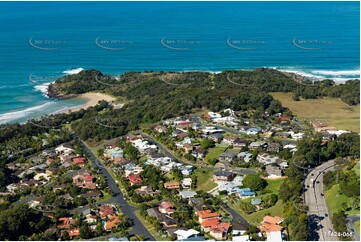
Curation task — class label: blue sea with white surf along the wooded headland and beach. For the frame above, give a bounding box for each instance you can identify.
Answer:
[0,2,360,123]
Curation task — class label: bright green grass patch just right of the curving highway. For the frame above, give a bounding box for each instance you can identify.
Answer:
[325,184,360,215]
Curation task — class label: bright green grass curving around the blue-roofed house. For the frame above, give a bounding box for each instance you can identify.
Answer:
[226,178,285,223]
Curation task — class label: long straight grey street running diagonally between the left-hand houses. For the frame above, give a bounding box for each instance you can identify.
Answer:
[74,136,155,241]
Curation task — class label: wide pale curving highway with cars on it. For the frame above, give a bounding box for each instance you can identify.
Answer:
[304,160,338,241]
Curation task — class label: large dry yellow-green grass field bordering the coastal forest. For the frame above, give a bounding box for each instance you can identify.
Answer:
[270,92,360,133]
